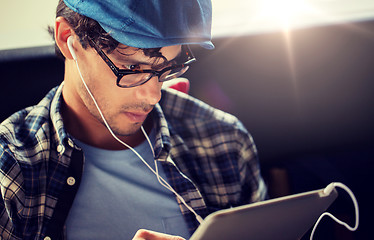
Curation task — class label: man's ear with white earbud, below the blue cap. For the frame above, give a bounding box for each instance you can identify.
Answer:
[55,17,75,59]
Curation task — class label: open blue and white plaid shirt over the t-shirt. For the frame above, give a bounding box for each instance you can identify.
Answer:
[0,84,266,240]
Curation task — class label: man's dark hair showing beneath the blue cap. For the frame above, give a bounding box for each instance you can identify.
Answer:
[48,0,166,60]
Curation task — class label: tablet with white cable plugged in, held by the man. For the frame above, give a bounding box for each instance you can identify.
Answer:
[190,185,338,240]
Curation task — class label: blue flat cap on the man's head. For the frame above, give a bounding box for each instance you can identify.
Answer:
[64,0,214,49]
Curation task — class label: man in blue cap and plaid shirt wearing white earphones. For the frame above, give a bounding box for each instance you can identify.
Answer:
[0,0,266,239]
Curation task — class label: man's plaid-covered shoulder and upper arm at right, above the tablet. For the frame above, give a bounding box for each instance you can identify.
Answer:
[161,90,262,205]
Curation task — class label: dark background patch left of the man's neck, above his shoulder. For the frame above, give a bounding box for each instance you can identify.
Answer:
[0,46,64,118]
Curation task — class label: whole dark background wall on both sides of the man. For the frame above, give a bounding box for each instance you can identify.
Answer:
[0,21,374,239]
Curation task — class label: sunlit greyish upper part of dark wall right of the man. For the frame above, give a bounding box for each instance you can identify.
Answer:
[186,22,374,161]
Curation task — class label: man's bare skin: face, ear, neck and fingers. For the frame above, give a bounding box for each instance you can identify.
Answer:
[55,17,183,240]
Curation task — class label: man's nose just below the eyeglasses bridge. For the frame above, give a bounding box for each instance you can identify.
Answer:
[135,76,162,105]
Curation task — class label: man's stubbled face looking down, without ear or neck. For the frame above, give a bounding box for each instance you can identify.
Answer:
[68,41,181,136]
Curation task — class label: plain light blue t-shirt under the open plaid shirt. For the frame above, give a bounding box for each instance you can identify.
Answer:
[66,131,190,240]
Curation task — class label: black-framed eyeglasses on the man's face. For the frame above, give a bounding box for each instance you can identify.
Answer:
[90,40,196,88]
